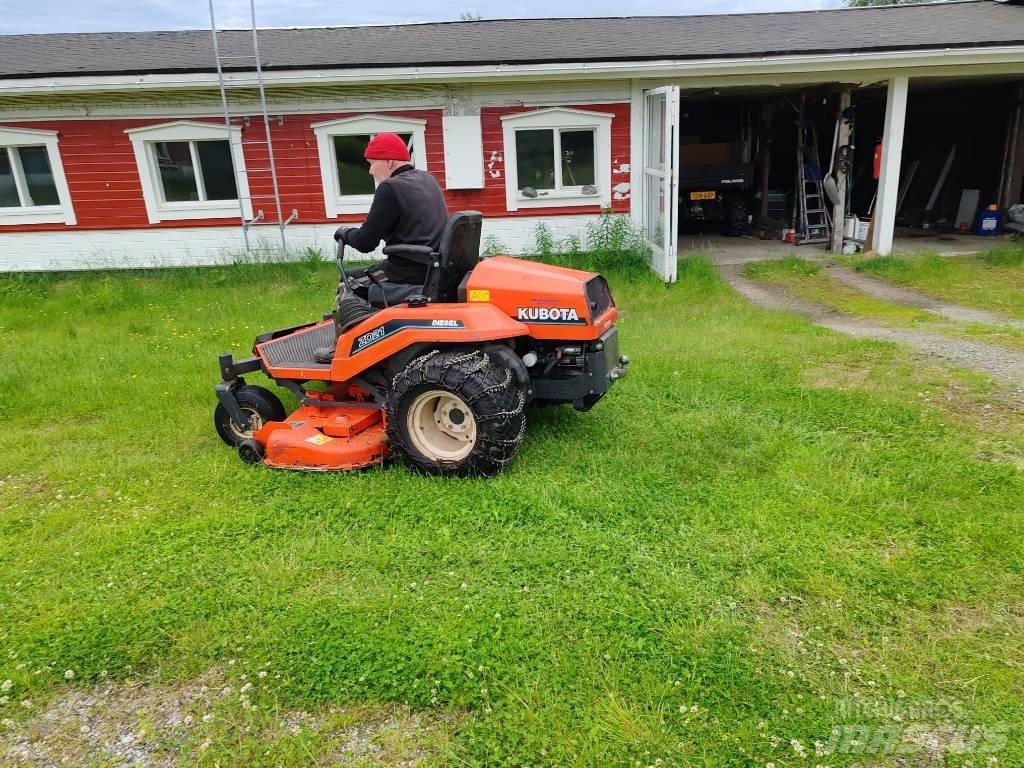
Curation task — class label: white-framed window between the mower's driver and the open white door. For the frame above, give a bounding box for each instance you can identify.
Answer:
[502,106,614,211]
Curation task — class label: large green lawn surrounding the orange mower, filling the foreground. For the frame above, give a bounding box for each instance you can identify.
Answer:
[0,258,1024,768]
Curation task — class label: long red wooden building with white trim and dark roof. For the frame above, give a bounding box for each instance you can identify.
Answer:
[0,0,1024,281]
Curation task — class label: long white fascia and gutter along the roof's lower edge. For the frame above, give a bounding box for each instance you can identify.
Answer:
[0,45,1024,95]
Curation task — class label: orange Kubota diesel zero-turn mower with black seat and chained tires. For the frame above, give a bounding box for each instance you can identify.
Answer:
[214,211,629,475]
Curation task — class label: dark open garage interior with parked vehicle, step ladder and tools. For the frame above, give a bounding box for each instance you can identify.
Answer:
[678,77,1024,259]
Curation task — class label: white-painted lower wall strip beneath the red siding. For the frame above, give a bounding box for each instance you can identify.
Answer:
[0,216,614,272]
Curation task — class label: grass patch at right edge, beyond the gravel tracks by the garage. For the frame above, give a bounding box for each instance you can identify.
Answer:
[847,243,1024,319]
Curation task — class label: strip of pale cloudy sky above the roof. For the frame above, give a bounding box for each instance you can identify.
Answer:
[0,0,842,35]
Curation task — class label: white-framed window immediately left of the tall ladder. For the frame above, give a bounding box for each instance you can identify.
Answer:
[125,120,253,224]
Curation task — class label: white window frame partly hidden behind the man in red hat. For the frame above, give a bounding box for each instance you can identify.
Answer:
[310,115,427,218]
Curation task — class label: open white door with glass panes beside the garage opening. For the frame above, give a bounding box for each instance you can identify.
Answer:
[643,85,679,283]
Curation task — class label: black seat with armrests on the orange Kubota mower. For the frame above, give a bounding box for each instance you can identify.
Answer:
[380,211,483,306]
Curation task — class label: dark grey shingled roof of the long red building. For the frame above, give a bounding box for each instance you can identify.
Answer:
[0,0,1024,78]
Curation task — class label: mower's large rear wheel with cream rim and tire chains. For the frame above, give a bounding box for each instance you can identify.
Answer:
[387,349,526,476]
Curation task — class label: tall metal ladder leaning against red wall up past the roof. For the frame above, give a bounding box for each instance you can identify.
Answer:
[209,0,299,253]
